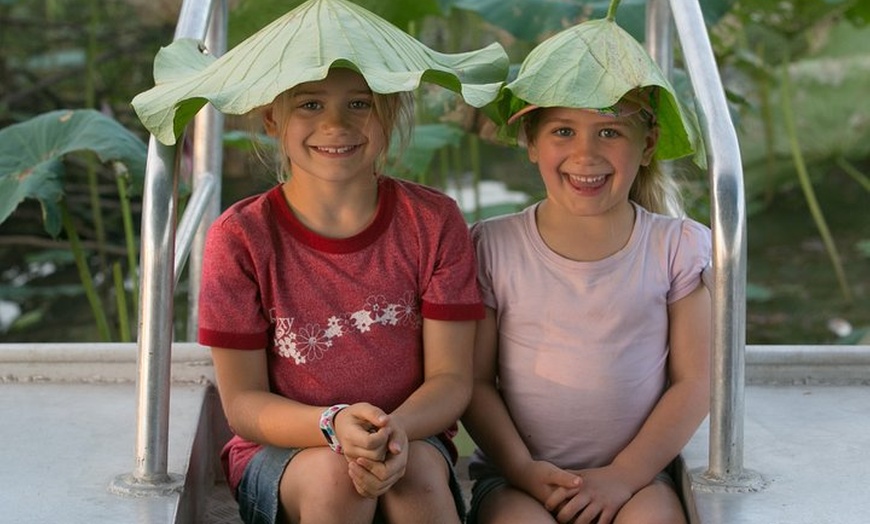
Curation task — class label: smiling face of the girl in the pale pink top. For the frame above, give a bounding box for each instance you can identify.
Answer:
[527,107,658,220]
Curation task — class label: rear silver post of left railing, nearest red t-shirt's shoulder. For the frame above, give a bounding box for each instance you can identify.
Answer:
[187,0,227,340]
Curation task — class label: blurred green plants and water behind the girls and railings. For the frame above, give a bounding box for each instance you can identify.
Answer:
[0,0,870,344]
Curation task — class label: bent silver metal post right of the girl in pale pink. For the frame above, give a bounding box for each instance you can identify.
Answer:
[670,0,753,489]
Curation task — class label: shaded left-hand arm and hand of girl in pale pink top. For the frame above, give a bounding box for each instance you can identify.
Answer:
[462,308,580,502]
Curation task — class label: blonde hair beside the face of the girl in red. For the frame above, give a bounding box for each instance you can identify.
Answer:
[262,74,414,182]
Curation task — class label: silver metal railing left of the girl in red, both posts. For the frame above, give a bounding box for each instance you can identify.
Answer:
[111,0,227,495]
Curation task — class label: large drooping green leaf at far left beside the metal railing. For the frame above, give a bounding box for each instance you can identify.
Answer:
[0,109,146,235]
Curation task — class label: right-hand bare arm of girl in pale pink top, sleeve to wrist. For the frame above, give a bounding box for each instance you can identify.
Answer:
[612,284,711,492]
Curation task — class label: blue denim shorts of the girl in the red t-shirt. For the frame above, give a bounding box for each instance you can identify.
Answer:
[236,436,465,524]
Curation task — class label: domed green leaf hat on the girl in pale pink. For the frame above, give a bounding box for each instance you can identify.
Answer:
[490,18,703,162]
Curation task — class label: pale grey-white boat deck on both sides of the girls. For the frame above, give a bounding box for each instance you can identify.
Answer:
[0,344,870,524]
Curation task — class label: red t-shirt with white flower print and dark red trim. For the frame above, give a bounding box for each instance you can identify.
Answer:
[199,177,483,489]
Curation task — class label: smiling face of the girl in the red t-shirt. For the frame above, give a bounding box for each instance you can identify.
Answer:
[264,69,388,182]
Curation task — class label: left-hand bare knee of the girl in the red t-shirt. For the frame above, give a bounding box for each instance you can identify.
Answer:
[279,447,377,524]
